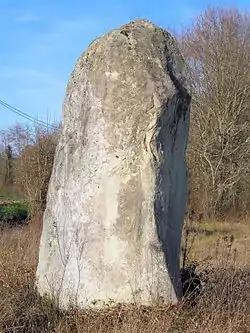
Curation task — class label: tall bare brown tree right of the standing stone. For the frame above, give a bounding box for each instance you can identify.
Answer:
[181,9,250,215]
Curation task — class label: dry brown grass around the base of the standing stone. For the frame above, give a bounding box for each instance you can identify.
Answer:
[0,219,250,333]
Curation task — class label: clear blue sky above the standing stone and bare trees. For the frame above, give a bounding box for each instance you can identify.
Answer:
[0,0,250,129]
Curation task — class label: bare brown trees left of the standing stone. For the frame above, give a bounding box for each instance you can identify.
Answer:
[0,124,60,213]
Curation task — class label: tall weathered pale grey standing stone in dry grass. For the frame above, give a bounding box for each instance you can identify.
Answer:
[37,20,190,308]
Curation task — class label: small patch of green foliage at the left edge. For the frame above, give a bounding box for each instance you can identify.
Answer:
[0,202,29,226]
